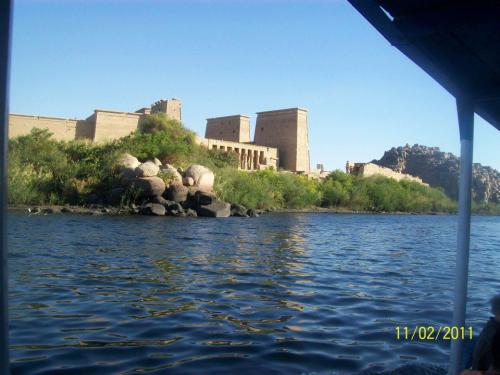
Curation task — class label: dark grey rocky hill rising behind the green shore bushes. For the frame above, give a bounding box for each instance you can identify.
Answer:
[372,145,500,203]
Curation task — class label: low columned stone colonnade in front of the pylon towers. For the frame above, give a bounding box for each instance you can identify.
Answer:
[200,138,279,171]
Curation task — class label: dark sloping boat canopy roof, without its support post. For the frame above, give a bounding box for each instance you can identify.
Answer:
[349,0,500,130]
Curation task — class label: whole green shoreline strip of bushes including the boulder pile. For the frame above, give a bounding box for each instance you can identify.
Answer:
[8,113,500,216]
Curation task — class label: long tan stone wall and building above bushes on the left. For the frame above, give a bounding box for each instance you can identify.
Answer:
[9,99,181,142]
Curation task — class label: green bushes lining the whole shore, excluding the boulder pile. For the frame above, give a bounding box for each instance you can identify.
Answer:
[8,128,468,213]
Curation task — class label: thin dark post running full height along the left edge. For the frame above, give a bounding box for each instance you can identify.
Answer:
[0,0,12,374]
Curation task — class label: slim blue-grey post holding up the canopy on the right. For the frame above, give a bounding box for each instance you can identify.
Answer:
[448,98,474,375]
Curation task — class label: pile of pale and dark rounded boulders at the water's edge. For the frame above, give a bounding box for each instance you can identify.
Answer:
[106,154,258,217]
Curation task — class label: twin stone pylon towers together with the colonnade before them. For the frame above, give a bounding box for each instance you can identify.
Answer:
[205,108,310,177]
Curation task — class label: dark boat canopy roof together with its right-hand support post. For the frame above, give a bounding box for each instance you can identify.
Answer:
[348,0,500,375]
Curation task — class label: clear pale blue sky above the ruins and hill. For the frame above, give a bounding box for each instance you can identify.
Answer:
[10,0,500,169]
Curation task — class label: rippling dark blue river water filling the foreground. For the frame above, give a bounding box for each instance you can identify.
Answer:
[9,214,500,374]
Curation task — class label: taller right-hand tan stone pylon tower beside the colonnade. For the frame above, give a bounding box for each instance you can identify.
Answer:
[254,108,310,173]
